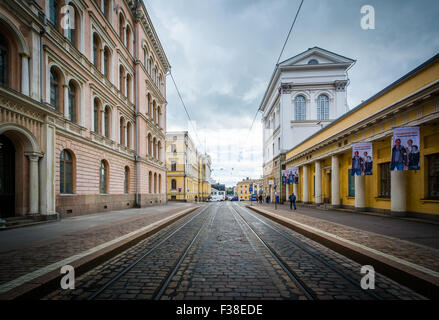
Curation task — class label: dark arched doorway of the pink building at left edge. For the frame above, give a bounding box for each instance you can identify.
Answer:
[0,135,15,218]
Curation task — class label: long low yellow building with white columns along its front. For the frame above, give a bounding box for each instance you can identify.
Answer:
[285,54,439,220]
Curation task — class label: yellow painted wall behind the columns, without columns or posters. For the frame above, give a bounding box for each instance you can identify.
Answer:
[286,57,439,215]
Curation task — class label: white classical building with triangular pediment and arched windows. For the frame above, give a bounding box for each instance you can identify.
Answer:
[259,47,355,200]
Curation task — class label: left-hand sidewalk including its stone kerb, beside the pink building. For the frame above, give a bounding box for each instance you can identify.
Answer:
[0,203,199,299]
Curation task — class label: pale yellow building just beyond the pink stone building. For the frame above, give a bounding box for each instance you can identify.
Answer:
[166,131,211,201]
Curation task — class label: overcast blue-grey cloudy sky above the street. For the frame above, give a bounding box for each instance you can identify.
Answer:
[145,0,439,186]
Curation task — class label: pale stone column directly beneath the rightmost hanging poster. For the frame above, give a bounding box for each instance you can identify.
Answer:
[390,170,407,216]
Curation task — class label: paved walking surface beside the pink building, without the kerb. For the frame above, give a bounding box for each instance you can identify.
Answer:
[0,203,197,294]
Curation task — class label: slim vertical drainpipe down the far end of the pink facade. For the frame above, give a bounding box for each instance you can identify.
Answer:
[133,2,141,208]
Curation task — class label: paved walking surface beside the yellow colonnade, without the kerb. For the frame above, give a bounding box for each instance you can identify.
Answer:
[246,203,439,272]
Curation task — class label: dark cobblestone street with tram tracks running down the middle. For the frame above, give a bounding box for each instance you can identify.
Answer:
[44,202,424,300]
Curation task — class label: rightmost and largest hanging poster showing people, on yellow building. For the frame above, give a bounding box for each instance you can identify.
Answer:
[390,127,421,171]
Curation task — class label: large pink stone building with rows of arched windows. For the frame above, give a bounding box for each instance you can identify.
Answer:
[0,0,170,219]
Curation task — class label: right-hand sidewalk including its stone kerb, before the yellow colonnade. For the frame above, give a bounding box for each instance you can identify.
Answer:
[246,203,439,296]
